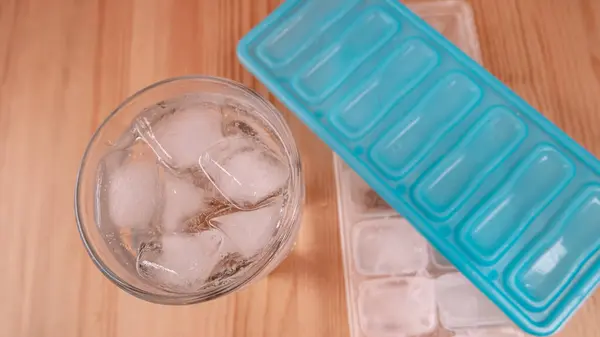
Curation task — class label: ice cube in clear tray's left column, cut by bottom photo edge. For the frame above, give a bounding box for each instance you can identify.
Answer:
[358,277,437,337]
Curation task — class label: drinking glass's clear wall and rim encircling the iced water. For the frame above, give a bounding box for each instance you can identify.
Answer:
[75,76,304,304]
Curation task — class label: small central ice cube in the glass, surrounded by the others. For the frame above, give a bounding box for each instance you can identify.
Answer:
[162,174,210,232]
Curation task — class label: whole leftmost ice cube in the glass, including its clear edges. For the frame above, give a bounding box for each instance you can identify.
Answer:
[96,144,162,230]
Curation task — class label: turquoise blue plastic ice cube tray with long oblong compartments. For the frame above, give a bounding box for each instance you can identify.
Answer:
[238,0,600,335]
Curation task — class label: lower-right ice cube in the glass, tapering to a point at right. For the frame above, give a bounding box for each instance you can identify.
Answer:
[211,198,282,258]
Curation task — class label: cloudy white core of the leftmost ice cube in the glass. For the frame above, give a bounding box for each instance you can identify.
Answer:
[105,161,161,229]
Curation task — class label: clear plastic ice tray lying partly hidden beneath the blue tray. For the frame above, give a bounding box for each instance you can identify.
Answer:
[333,0,524,337]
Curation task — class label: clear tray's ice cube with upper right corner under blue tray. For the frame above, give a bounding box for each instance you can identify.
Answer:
[352,217,429,275]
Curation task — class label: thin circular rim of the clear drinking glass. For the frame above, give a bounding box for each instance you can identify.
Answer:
[74,75,304,305]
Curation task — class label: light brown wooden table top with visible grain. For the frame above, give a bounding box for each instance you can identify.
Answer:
[0,0,600,337]
